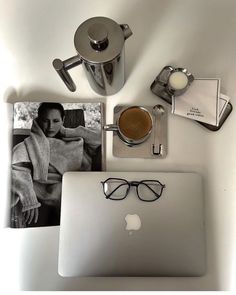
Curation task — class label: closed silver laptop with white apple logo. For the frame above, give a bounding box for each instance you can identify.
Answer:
[58,172,205,277]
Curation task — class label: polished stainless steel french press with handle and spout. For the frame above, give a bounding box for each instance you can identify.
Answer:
[53,17,132,95]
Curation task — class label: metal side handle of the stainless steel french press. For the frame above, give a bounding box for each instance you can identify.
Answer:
[52,55,82,92]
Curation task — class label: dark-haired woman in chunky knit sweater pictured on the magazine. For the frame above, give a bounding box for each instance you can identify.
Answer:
[11,103,101,227]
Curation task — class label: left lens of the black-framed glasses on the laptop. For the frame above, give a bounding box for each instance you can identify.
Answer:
[103,178,129,200]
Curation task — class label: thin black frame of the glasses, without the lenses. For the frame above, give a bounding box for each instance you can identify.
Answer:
[101,177,166,202]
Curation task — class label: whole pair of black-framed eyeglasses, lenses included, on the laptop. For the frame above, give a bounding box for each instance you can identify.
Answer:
[101,178,165,202]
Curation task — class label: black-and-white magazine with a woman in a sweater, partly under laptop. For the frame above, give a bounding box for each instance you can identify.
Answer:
[10,102,103,228]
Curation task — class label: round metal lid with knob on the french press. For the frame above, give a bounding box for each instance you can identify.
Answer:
[74,17,125,63]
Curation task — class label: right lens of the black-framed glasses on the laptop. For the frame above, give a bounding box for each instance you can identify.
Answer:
[137,180,163,202]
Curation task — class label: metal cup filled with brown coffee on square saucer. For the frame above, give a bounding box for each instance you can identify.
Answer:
[103,106,153,145]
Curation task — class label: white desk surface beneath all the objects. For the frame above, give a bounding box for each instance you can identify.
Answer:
[0,0,236,290]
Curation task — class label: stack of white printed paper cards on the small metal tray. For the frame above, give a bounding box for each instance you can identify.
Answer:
[172,79,229,126]
